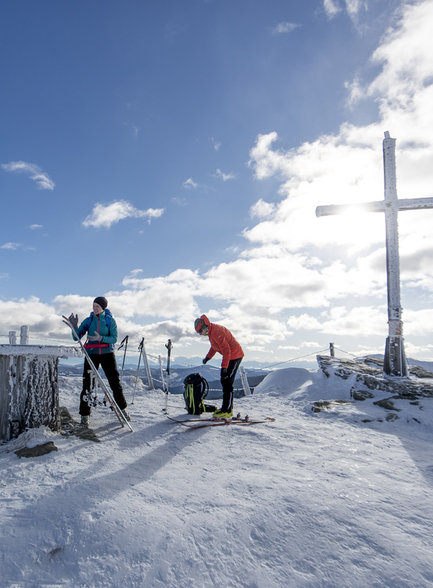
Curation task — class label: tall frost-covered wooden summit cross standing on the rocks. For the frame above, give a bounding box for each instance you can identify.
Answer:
[316,131,433,376]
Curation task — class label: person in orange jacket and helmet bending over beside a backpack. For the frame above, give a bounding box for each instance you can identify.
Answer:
[194,314,244,418]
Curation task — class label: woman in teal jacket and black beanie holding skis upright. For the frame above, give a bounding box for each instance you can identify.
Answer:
[69,296,130,427]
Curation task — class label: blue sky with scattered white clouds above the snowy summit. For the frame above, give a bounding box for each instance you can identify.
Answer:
[0,0,433,362]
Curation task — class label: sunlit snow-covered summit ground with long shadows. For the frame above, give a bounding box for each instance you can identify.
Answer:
[0,368,433,588]
